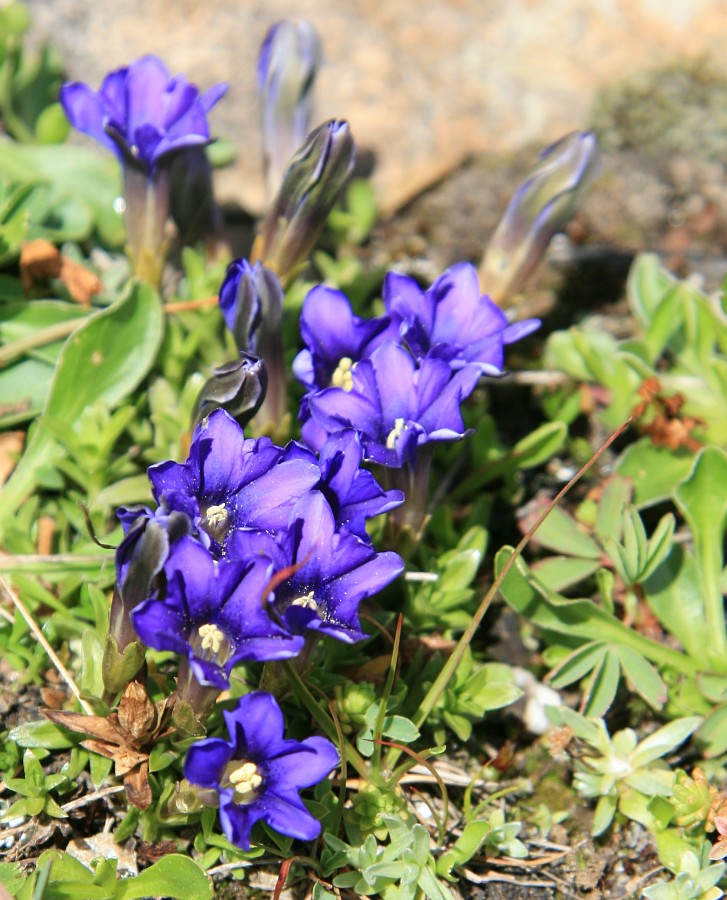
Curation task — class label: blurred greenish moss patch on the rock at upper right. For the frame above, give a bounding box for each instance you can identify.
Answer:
[591,59,727,161]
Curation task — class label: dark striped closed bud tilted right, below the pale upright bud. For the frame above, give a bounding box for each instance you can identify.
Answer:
[252,119,356,283]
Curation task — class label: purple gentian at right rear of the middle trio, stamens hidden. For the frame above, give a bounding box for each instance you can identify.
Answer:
[383,263,540,375]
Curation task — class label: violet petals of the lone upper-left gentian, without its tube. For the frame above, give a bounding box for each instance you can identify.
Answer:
[60,56,227,172]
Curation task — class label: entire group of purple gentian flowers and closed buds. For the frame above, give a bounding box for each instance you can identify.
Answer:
[61,22,598,848]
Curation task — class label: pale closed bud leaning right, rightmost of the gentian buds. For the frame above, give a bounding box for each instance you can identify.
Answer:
[479,131,599,303]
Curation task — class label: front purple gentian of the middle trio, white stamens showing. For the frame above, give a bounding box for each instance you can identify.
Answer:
[303,341,480,468]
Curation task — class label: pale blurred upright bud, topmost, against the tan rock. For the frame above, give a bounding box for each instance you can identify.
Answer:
[257,20,322,199]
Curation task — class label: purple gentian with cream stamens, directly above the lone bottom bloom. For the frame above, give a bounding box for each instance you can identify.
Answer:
[131,537,303,690]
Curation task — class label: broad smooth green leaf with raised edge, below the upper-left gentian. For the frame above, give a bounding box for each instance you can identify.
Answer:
[0,283,164,537]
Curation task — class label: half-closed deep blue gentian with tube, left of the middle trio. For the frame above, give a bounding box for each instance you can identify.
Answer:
[219,259,288,430]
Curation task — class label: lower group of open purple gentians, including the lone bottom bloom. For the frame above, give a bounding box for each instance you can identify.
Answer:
[116,409,403,846]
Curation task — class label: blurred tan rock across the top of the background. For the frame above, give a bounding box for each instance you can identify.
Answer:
[28,0,727,213]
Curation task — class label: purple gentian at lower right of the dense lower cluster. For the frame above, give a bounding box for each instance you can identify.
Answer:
[231,491,404,643]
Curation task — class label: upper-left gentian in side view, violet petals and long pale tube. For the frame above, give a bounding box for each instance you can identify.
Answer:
[60,56,227,284]
